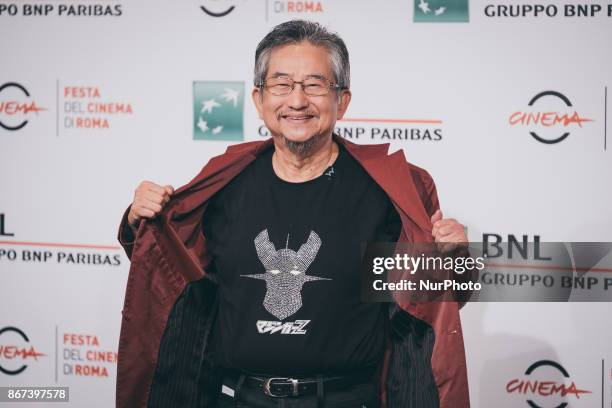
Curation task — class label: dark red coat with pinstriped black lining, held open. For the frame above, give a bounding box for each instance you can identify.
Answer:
[116,137,469,408]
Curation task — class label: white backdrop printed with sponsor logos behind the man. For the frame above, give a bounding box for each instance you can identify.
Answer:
[0,0,612,407]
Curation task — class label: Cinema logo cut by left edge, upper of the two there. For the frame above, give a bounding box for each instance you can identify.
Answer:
[0,82,47,131]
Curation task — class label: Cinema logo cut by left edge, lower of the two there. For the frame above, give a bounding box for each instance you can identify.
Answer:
[0,326,46,375]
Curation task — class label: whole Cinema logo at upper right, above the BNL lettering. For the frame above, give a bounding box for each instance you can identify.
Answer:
[508,91,593,144]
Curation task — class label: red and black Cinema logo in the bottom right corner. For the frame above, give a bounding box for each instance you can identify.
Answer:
[506,360,591,408]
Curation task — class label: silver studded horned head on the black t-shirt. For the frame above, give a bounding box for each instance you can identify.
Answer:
[241,229,330,320]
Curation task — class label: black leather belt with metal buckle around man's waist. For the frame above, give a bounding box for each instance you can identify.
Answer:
[226,368,374,397]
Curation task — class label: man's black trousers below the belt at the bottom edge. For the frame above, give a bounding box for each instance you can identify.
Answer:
[217,378,379,408]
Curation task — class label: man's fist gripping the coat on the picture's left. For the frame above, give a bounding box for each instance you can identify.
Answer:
[128,181,174,229]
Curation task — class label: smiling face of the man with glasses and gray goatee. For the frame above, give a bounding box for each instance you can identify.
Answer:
[252,42,351,150]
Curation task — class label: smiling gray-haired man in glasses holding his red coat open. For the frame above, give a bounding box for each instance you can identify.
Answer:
[117,21,469,408]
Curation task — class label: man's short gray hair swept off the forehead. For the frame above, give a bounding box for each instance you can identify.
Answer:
[253,20,351,89]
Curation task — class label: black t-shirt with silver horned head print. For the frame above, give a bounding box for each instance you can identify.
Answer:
[203,146,401,375]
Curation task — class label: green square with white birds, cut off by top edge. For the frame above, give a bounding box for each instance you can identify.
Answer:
[414,0,470,23]
